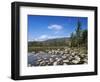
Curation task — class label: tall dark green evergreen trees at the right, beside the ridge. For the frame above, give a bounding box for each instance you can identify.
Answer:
[70,20,87,48]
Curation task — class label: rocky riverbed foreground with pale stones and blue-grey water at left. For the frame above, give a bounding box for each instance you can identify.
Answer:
[28,48,88,67]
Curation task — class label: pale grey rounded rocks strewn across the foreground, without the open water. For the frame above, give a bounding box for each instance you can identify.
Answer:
[28,48,88,66]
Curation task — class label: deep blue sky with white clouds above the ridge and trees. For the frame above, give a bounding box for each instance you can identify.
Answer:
[28,15,88,41]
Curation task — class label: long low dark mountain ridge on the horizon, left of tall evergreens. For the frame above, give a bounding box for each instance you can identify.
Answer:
[28,37,70,46]
